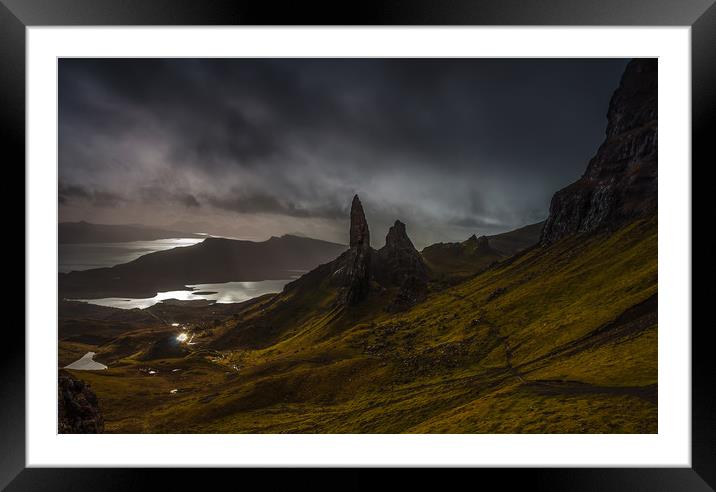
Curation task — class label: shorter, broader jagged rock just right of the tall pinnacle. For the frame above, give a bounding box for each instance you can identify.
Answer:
[373,220,428,311]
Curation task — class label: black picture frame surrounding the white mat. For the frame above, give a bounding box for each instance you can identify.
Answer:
[0,0,716,491]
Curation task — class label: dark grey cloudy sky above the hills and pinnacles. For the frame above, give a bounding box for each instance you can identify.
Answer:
[59,59,627,248]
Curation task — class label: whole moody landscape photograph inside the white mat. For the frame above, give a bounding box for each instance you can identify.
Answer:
[58,57,656,439]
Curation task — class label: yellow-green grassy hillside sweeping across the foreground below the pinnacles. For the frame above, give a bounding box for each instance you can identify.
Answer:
[70,219,657,433]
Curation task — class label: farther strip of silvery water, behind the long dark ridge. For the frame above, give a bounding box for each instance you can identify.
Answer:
[59,238,204,273]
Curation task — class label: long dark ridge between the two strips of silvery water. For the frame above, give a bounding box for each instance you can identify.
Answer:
[59,235,346,299]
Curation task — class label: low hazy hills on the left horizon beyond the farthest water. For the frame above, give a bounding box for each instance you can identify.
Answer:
[57,221,204,244]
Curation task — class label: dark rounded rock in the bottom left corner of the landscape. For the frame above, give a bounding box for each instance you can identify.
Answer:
[57,371,104,434]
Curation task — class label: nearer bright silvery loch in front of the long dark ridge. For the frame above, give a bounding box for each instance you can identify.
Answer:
[77,279,293,309]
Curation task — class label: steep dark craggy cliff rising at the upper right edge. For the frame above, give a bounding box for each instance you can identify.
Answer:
[540,59,657,245]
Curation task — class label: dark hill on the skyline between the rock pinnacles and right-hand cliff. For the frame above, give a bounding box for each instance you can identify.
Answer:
[421,222,544,279]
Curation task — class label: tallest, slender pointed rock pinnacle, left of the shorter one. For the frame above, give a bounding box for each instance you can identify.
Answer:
[341,195,372,304]
